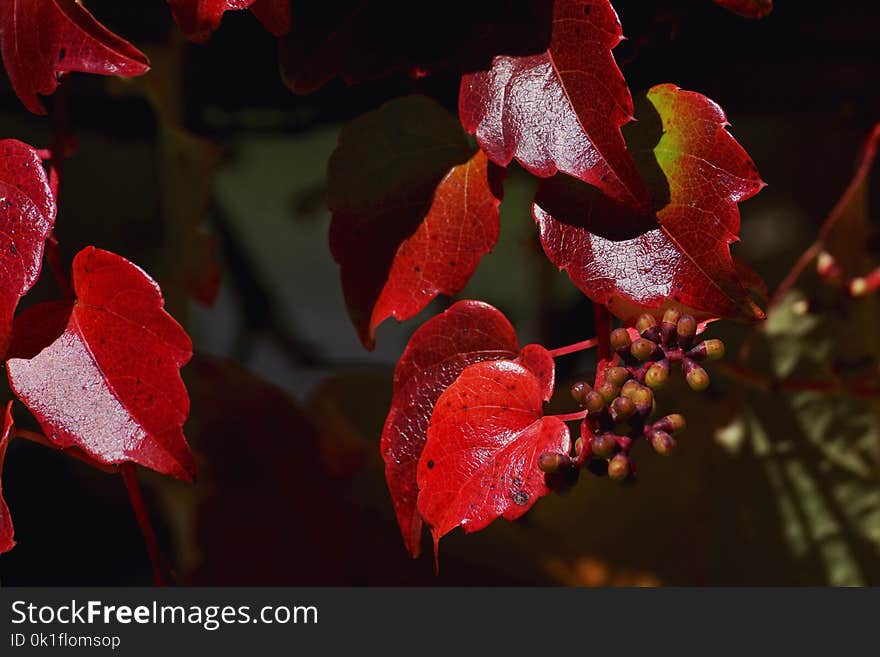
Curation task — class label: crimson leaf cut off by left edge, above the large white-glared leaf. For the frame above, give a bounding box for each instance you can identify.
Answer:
[0,139,56,354]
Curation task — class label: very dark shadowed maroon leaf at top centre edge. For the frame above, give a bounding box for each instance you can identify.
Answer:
[280,0,552,93]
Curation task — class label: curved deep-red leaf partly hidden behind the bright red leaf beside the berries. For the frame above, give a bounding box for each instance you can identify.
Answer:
[382,301,519,557]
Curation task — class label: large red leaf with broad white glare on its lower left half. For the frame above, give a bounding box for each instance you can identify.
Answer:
[6,247,195,480]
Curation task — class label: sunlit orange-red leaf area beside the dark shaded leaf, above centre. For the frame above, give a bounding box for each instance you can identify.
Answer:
[369,151,501,340]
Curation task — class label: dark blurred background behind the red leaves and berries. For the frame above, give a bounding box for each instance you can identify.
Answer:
[0,0,880,586]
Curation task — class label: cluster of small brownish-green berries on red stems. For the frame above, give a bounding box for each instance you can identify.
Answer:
[538,309,724,480]
